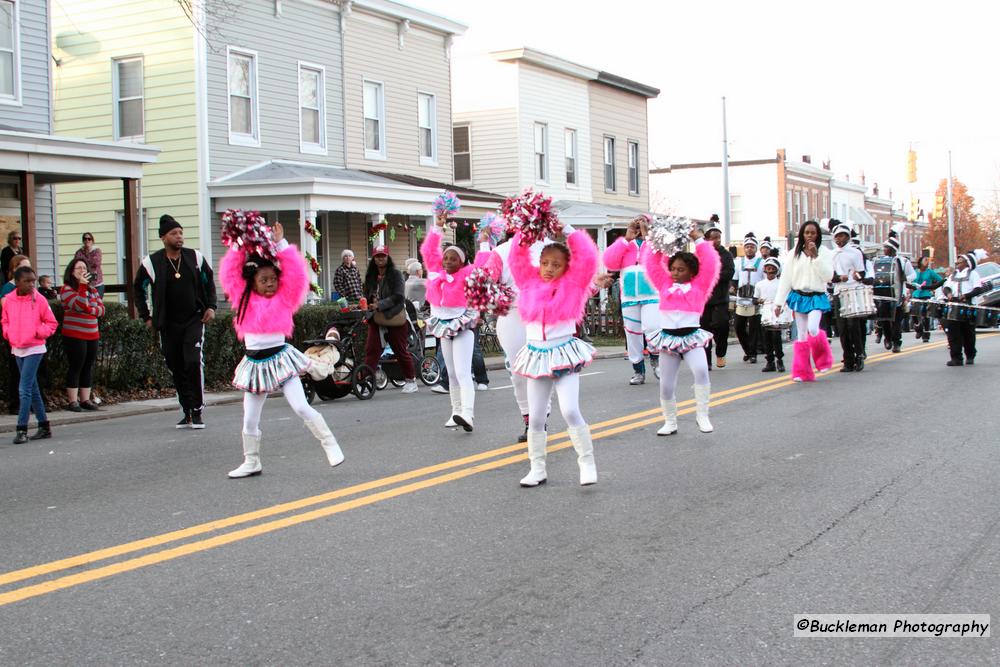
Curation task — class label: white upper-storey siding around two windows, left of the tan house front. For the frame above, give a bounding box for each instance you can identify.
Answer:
[518,63,592,201]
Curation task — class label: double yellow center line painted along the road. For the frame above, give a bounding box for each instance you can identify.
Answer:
[0,342,972,606]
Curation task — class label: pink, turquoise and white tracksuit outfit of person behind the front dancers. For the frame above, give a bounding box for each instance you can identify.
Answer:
[603,236,660,385]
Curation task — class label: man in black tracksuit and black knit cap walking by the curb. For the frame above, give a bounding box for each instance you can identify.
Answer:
[133,214,217,429]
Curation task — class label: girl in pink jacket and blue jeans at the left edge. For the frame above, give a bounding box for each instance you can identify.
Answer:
[0,266,59,445]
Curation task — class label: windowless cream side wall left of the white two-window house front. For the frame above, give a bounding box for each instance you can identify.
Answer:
[454,108,520,194]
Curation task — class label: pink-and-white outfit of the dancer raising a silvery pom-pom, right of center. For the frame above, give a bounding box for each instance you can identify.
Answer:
[642,239,722,435]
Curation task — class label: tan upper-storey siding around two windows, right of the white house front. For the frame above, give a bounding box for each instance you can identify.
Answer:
[589,82,649,210]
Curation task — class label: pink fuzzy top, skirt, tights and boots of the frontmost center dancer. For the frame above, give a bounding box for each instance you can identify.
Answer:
[509,225,597,486]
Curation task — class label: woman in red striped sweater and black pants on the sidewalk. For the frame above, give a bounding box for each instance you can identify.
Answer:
[59,258,104,412]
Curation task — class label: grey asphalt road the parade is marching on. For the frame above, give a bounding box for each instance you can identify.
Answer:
[0,335,1000,665]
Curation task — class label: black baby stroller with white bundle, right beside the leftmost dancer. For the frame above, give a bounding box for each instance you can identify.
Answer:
[303,311,375,403]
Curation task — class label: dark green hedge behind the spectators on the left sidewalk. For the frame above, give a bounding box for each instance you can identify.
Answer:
[0,301,363,408]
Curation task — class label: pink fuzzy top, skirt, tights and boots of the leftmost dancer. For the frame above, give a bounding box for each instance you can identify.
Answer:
[219,239,344,478]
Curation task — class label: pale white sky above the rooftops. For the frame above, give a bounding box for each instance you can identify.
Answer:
[403,0,1000,210]
